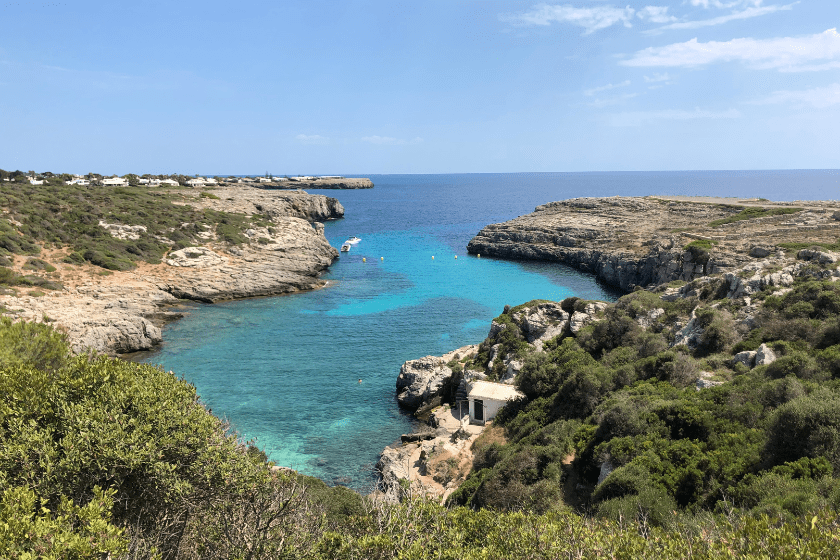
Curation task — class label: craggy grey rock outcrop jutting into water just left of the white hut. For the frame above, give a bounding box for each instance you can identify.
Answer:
[397,345,478,410]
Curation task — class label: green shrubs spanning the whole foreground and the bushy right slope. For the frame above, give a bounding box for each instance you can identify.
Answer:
[0,282,840,560]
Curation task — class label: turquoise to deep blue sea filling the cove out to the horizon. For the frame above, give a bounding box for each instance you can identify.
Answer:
[143,170,840,492]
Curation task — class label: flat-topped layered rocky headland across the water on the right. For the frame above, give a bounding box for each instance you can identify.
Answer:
[467,197,840,291]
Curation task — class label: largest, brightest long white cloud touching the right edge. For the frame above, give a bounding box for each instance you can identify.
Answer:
[619,28,840,72]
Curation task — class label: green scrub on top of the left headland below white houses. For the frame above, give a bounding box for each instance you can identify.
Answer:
[0,180,268,274]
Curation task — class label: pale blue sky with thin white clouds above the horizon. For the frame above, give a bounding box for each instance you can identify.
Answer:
[0,0,840,175]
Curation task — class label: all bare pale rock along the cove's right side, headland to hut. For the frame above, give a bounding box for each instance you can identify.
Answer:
[377,197,840,498]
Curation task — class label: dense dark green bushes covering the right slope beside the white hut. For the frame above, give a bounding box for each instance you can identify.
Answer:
[450,265,840,525]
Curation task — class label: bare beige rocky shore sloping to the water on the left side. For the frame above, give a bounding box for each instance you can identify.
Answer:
[0,186,344,355]
